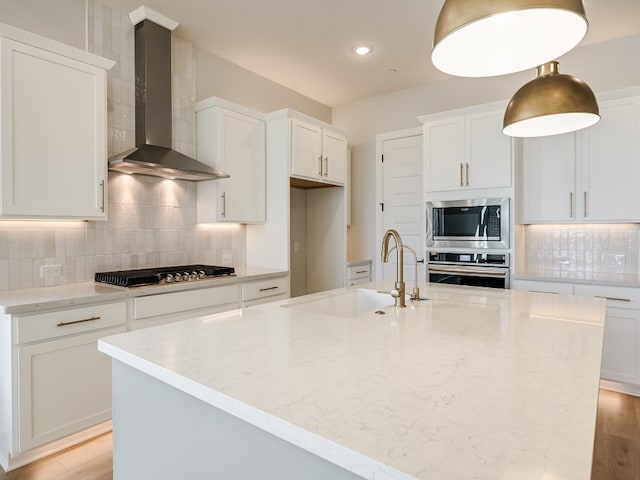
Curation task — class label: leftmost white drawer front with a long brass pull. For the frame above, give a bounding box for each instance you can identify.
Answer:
[16,302,127,344]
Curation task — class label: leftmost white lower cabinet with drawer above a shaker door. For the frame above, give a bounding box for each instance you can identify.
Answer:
[0,301,127,470]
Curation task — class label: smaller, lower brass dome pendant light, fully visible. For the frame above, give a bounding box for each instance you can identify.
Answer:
[503,62,600,137]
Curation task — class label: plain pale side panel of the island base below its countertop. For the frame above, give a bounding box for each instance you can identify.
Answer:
[113,361,370,480]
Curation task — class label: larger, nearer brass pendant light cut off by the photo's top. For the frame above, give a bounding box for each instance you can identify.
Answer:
[431,0,588,77]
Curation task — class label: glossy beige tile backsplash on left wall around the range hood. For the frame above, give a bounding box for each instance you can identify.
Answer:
[0,0,246,290]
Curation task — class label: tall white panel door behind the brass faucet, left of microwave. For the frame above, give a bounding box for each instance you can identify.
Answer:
[376,135,426,284]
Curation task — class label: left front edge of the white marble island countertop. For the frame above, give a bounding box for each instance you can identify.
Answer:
[98,332,415,480]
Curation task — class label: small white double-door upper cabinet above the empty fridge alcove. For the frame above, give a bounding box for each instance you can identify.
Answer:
[291,118,347,185]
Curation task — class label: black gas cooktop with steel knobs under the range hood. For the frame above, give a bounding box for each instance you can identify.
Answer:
[95,265,235,287]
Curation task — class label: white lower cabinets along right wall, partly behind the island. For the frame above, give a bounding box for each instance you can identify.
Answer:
[512,280,640,393]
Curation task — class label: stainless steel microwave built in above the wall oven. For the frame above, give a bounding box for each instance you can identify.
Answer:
[426,198,509,248]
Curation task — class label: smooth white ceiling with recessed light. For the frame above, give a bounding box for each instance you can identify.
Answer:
[104,0,640,107]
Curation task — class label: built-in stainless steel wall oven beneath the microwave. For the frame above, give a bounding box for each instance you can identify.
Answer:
[427,252,509,288]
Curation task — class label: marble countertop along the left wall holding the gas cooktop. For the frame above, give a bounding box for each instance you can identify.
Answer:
[0,267,289,314]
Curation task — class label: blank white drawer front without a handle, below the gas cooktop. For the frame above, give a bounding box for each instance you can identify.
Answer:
[133,285,238,320]
